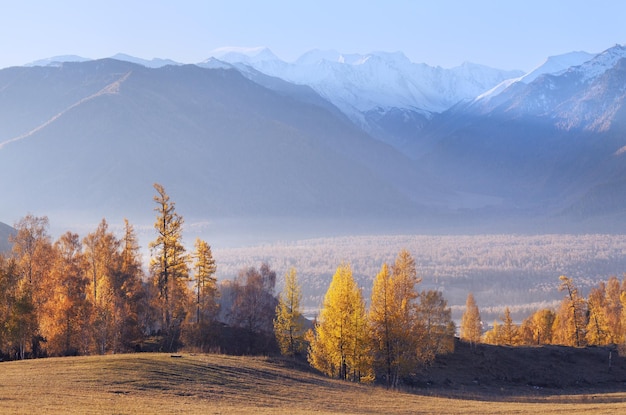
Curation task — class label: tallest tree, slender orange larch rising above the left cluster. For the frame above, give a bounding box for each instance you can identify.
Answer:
[150,183,189,350]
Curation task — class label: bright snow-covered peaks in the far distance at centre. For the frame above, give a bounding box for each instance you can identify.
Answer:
[205,48,523,121]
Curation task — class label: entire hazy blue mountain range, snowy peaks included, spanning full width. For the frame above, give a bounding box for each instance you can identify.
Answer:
[0,45,626,242]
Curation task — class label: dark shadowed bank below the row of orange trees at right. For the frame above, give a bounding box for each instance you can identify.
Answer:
[416,339,626,396]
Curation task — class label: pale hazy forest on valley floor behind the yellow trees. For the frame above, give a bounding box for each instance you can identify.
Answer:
[214,234,626,322]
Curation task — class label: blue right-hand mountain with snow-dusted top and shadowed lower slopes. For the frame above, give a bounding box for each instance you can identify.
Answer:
[411,45,626,228]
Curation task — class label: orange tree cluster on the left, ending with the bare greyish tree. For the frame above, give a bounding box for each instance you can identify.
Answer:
[0,184,277,359]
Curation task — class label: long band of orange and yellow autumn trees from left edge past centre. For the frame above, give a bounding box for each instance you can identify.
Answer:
[0,184,455,386]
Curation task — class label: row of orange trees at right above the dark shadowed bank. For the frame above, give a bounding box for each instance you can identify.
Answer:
[461,275,626,347]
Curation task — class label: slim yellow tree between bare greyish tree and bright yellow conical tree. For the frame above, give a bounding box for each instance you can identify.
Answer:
[274,267,304,356]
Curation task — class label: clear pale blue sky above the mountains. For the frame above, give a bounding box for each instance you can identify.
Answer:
[0,0,626,71]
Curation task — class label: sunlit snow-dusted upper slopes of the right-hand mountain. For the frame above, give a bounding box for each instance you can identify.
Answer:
[463,45,626,131]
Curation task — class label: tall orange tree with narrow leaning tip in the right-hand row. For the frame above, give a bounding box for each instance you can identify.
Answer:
[553,275,587,347]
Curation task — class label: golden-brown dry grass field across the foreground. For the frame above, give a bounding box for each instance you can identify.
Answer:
[0,354,626,414]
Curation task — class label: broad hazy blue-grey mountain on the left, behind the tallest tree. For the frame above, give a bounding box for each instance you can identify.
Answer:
[0,59,445,236]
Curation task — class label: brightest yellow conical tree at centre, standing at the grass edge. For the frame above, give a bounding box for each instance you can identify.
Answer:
[308,264,371,381]
